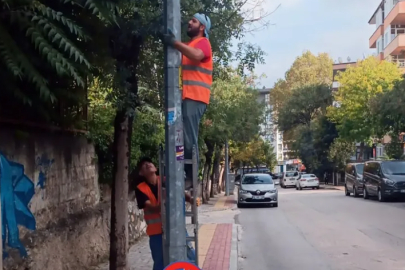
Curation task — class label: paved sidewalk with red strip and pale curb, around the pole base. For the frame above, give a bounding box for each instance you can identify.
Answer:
[96,194,238,270]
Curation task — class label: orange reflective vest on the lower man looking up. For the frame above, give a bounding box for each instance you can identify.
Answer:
[137,178,163,235]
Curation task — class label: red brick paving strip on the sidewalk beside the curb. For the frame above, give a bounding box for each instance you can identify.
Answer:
[202,224,232,270]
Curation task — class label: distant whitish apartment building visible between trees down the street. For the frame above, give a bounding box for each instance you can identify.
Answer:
[257,87,283,172]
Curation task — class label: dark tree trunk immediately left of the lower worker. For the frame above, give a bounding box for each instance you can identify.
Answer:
[110,111,129,270]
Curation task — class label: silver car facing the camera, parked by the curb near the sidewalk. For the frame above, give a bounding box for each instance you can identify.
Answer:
[236,173,278,207]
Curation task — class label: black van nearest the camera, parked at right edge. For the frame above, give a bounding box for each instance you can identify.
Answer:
[363,160,405,202]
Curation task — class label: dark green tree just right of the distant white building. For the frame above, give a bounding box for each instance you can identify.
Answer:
[277,84,337,173]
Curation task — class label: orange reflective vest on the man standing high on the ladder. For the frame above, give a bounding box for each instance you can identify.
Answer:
[181,37,213,104]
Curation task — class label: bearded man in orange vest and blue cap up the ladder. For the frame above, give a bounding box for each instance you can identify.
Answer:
[162,13,213,189]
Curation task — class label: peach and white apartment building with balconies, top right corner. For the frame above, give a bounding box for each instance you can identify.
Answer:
[369,0,405,68]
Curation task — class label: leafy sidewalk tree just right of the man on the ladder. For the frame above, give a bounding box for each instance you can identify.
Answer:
[200,69,264,202]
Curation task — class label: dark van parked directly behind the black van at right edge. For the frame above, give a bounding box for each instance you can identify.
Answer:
[345,163,364,197]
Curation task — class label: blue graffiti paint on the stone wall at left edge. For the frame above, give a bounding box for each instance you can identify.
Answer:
[0,153,36,258]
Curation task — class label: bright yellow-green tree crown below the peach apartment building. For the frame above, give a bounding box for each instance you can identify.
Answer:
[328,56,401,141]
